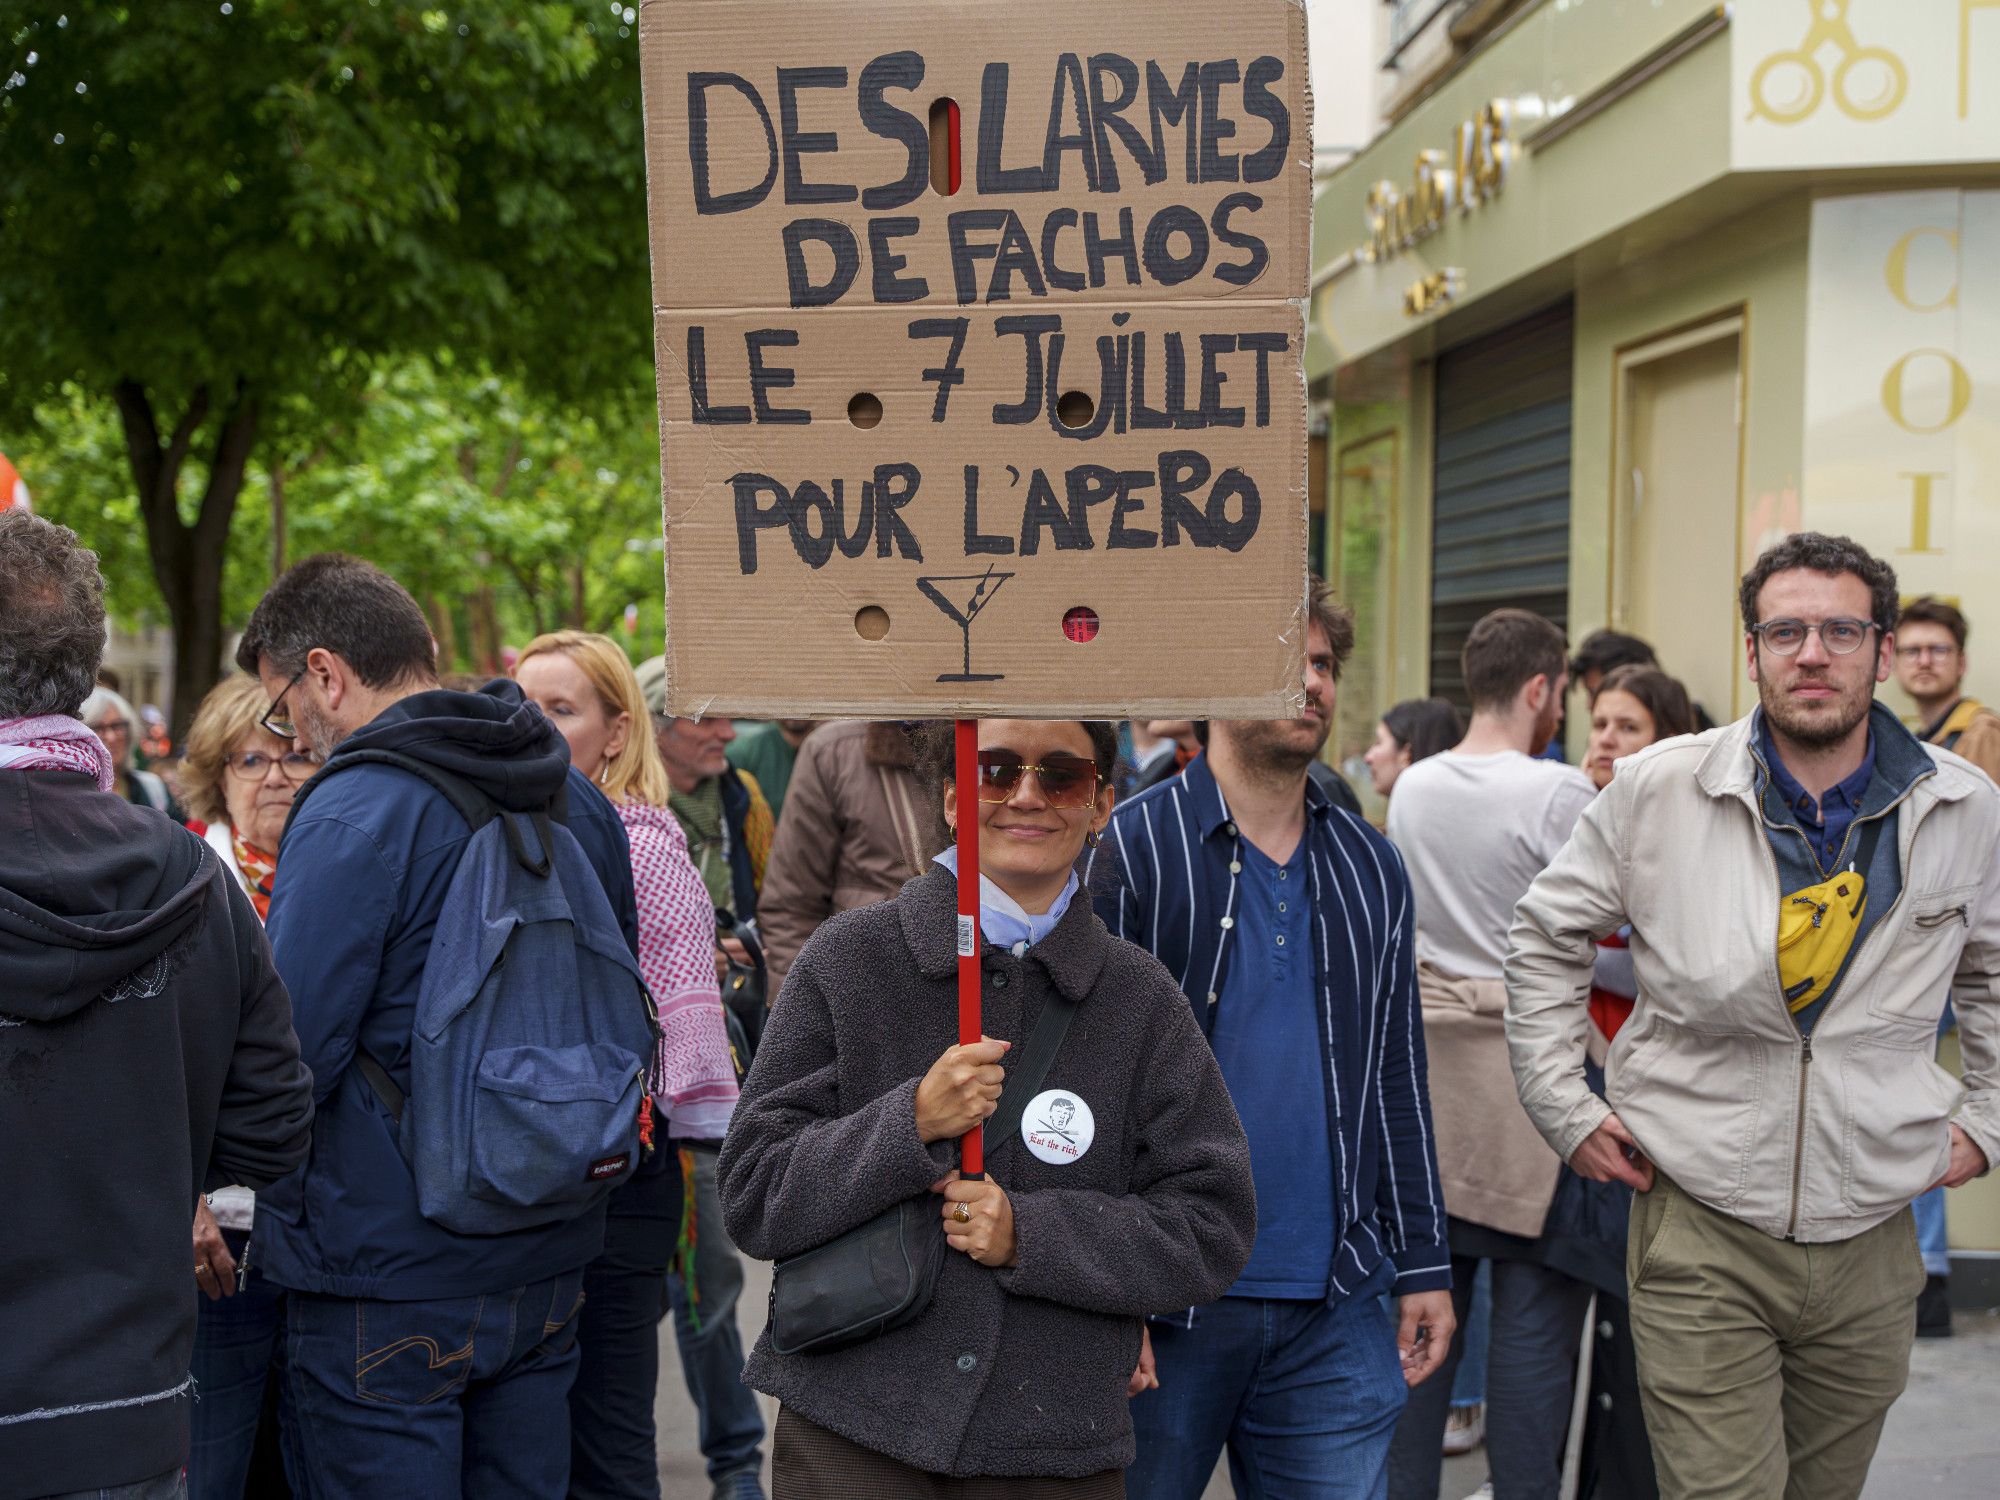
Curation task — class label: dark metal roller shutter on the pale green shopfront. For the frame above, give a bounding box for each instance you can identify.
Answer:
[1430,302,1574,708]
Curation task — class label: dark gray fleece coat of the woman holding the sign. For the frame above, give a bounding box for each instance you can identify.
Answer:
[718,868,1256,1478]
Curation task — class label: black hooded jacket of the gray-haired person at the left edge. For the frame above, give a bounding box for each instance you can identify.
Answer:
[0,770,312,1500]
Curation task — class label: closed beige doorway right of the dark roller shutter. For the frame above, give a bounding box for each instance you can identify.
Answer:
[1610,312,1744,720]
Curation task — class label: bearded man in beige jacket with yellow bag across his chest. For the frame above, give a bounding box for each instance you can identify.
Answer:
[1506,532,2000,1500]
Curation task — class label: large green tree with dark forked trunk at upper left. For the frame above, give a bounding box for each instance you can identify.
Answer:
[0,0,650,732]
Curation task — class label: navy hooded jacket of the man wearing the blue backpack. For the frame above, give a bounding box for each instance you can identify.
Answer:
[256,682,638,1302]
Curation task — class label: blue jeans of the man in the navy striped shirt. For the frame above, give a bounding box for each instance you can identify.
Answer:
[1126,1264,1408,1500]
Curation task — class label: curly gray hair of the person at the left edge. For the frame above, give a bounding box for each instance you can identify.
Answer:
[0,508,104,718]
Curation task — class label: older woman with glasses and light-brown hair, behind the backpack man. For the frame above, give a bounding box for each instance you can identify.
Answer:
[176,674,320,1500]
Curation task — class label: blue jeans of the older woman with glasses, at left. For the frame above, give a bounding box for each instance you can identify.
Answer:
[188,1230,284,1500]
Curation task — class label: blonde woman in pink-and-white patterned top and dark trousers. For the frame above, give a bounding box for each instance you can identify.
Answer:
[514,630,740,1500]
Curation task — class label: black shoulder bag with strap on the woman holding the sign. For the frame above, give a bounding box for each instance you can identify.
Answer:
[770,988,1076,1354]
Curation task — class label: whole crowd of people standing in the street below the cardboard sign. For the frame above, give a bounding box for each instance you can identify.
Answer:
[0,512,2000,1500]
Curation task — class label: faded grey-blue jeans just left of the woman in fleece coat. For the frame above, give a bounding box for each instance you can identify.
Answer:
[666,1142,764,1480]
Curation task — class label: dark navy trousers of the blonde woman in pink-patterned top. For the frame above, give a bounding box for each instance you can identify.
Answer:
[568,1150,680,1500]
